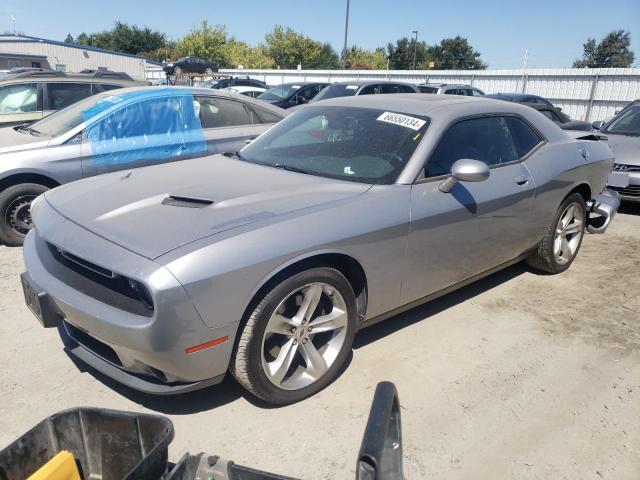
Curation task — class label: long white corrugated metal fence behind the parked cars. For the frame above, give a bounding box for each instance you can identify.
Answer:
[215,68,640,121]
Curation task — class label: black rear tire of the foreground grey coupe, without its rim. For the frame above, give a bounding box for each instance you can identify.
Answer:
[527,193,587,274]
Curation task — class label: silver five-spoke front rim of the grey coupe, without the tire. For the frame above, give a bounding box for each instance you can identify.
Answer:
[261,282,349,390]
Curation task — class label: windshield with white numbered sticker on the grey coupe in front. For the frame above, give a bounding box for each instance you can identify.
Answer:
[239,106,429,184]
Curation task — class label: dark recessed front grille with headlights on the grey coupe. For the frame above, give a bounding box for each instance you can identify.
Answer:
[36,237,154,317]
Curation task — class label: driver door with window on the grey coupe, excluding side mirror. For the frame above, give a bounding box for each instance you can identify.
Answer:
[402,116,542,302]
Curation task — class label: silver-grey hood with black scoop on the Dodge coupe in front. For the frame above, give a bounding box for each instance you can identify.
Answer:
[45,155,370,259]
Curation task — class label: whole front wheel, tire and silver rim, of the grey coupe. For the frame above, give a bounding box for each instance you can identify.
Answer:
[230,268,356,405]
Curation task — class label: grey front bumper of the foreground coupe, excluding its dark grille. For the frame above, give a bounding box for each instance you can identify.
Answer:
[24,205,238,394]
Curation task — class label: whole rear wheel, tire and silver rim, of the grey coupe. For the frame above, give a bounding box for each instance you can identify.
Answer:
[527,193,587,273]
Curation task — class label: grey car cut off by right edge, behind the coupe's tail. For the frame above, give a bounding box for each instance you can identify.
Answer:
[594,100,640,203]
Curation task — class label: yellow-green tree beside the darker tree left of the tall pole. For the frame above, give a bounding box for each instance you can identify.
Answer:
[265,25,322,68]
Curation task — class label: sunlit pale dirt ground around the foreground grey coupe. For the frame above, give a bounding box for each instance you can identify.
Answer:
[0,204,640,480]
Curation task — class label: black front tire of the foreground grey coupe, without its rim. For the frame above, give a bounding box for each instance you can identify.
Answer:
[229,267,357,405]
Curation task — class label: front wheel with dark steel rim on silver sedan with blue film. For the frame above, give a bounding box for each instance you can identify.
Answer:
[0,183,49,247]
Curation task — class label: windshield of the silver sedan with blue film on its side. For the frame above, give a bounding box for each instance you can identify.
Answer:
[29,93,123,137]
